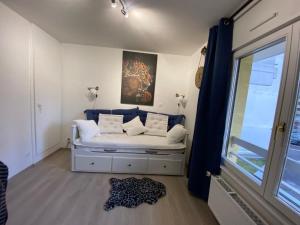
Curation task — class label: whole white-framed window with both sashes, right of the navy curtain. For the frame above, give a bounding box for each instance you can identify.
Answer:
[223,22,300,224]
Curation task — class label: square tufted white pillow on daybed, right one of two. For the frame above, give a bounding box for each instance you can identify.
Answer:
[145,113,169,137]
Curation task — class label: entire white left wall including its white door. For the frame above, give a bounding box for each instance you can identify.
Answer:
[0,3,62,177]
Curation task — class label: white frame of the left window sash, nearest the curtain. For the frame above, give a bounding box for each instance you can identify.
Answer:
[222,26,292,196]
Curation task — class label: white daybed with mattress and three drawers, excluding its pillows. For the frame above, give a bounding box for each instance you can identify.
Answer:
[72,107,187,175]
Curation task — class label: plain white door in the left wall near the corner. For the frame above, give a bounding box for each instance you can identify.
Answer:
[33,27,61,157]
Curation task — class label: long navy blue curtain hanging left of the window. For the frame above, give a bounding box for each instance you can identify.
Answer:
[188,18,233,200]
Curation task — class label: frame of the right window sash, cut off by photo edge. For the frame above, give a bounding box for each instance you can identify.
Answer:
[264,21,300,223]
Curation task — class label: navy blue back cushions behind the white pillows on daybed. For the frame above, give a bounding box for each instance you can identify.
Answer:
[84,108,185,131]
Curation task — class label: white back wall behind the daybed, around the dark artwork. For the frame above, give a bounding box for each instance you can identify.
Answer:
[63,44,191,140]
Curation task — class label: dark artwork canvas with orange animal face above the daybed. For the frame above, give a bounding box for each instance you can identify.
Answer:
[121,51,157,106]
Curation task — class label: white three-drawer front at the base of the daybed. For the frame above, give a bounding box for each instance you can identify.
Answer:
[72,148,185,175]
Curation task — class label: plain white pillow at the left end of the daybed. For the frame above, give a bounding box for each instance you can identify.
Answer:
[74,120,100,142]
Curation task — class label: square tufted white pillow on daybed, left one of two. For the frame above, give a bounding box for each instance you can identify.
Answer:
[98,113,123,134]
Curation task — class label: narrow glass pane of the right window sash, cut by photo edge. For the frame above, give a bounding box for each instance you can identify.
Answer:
[278,89,300,212]
